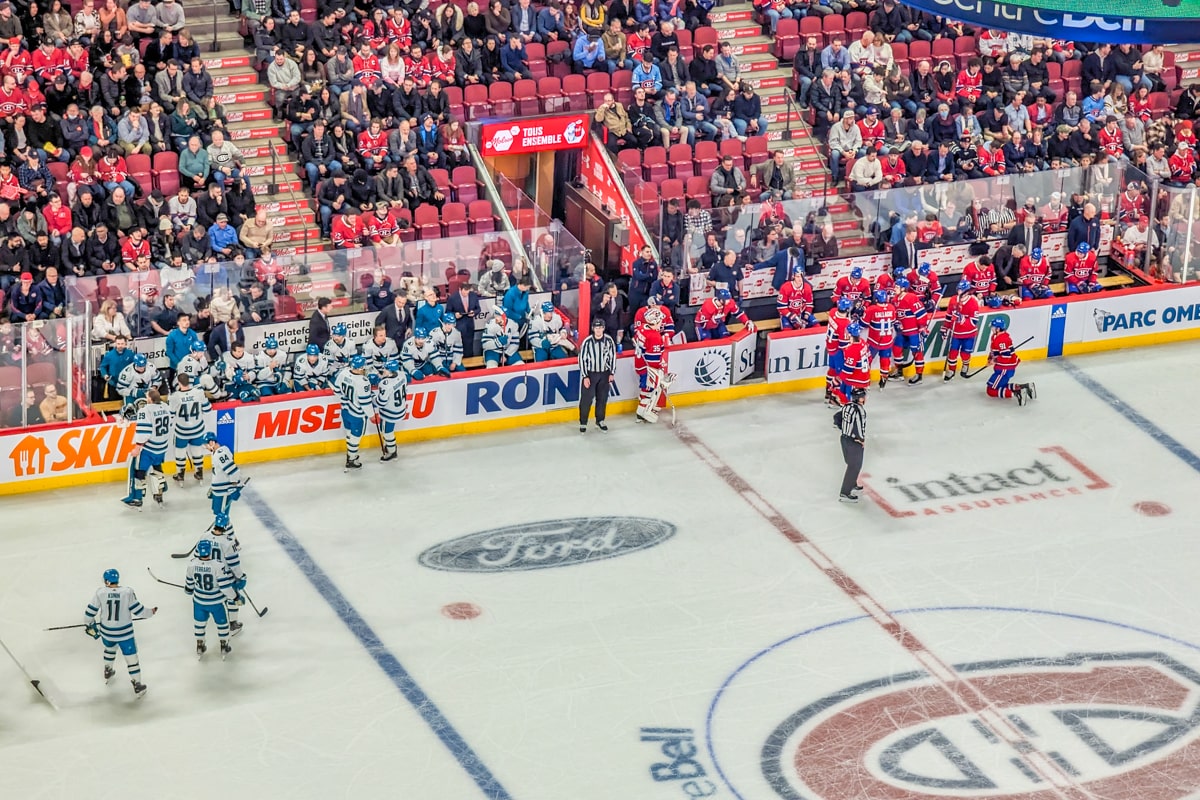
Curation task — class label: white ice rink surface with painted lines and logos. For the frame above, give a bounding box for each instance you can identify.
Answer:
[0,345,1200,800]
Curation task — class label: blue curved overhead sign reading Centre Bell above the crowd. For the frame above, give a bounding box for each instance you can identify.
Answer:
[905,0,1200,44]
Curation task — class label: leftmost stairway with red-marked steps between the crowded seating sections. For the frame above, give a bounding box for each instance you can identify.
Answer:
[182,0,316,255]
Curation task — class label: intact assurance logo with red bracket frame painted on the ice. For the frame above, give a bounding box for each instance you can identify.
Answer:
[864,446,1110,518]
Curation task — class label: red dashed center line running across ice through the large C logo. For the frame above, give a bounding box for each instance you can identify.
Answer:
[670,423,1096,800]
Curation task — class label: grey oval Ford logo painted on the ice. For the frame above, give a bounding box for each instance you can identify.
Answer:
[418,517,676,572]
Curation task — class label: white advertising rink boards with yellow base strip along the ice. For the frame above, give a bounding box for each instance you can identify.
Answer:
[7,285,1200,495]
